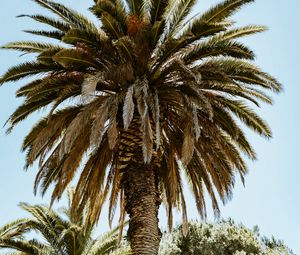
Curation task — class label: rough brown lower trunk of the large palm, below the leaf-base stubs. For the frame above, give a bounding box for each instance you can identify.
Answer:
[123,161,161,255]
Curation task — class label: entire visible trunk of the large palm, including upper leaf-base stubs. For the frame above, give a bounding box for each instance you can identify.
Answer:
[120,118,161,255]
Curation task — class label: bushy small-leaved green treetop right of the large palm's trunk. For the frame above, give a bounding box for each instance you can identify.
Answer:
[160,220,295,255]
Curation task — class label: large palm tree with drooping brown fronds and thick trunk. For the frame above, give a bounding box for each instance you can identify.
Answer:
[0,0,281,255]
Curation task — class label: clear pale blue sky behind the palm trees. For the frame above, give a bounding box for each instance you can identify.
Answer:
[0,0,300,254]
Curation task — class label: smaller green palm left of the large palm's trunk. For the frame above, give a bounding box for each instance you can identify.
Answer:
[0,192,131,255]
